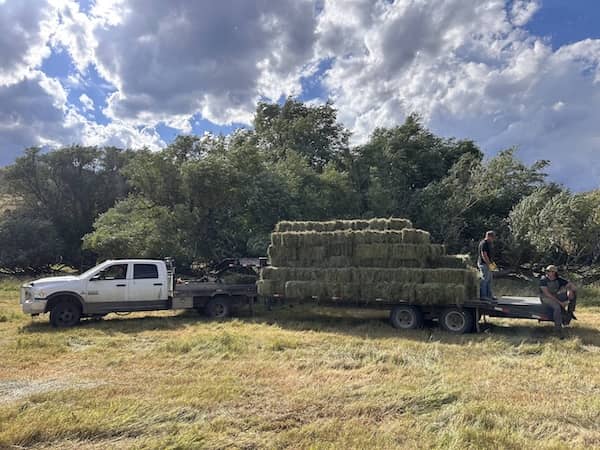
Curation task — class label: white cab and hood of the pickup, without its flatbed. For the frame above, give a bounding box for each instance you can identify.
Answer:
[20,259,173,327]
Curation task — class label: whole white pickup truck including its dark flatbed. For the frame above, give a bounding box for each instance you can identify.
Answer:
[21,259,257,327]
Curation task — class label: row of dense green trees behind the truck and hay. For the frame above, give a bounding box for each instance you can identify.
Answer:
[0,98,600,273]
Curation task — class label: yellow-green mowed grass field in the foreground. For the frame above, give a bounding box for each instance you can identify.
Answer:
[0,282,600,449]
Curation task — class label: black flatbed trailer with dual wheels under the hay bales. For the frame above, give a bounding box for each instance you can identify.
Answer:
[268,296,553,334]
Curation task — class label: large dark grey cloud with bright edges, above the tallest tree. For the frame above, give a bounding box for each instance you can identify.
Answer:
[93,0,316,124]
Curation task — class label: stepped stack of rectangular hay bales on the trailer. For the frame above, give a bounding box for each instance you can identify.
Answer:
[258,218,479,305]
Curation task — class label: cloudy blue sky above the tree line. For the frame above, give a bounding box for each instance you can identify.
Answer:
[0,0,600,190]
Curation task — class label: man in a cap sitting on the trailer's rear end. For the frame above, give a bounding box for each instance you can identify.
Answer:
[540,265,577,330]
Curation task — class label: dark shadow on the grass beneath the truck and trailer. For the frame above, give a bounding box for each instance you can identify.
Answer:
[21,305,600,347]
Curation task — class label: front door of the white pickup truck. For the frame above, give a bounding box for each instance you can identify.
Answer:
[86,263,130,313]
